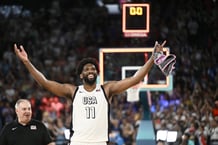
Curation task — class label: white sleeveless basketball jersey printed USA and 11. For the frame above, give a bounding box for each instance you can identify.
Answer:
[71,85,109,142]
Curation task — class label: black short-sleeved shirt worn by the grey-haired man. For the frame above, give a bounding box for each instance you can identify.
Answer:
[0,119,52,145]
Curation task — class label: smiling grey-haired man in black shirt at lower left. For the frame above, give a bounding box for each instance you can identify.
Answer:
[0,99,55,145]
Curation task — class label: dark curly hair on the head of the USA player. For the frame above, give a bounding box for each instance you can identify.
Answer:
[77,57,99,75]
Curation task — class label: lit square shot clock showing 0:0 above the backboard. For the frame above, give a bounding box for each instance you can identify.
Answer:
[122,3,150,37]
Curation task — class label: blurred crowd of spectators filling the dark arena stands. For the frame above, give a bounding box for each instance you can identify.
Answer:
[0,0,218,145]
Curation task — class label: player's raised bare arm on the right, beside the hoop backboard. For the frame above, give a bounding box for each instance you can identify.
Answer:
[104,41,166,96]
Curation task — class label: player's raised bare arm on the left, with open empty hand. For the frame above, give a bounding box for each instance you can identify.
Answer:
[14,44,75,97]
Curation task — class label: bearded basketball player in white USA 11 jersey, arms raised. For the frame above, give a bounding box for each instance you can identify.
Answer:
[14,41,166,145]
